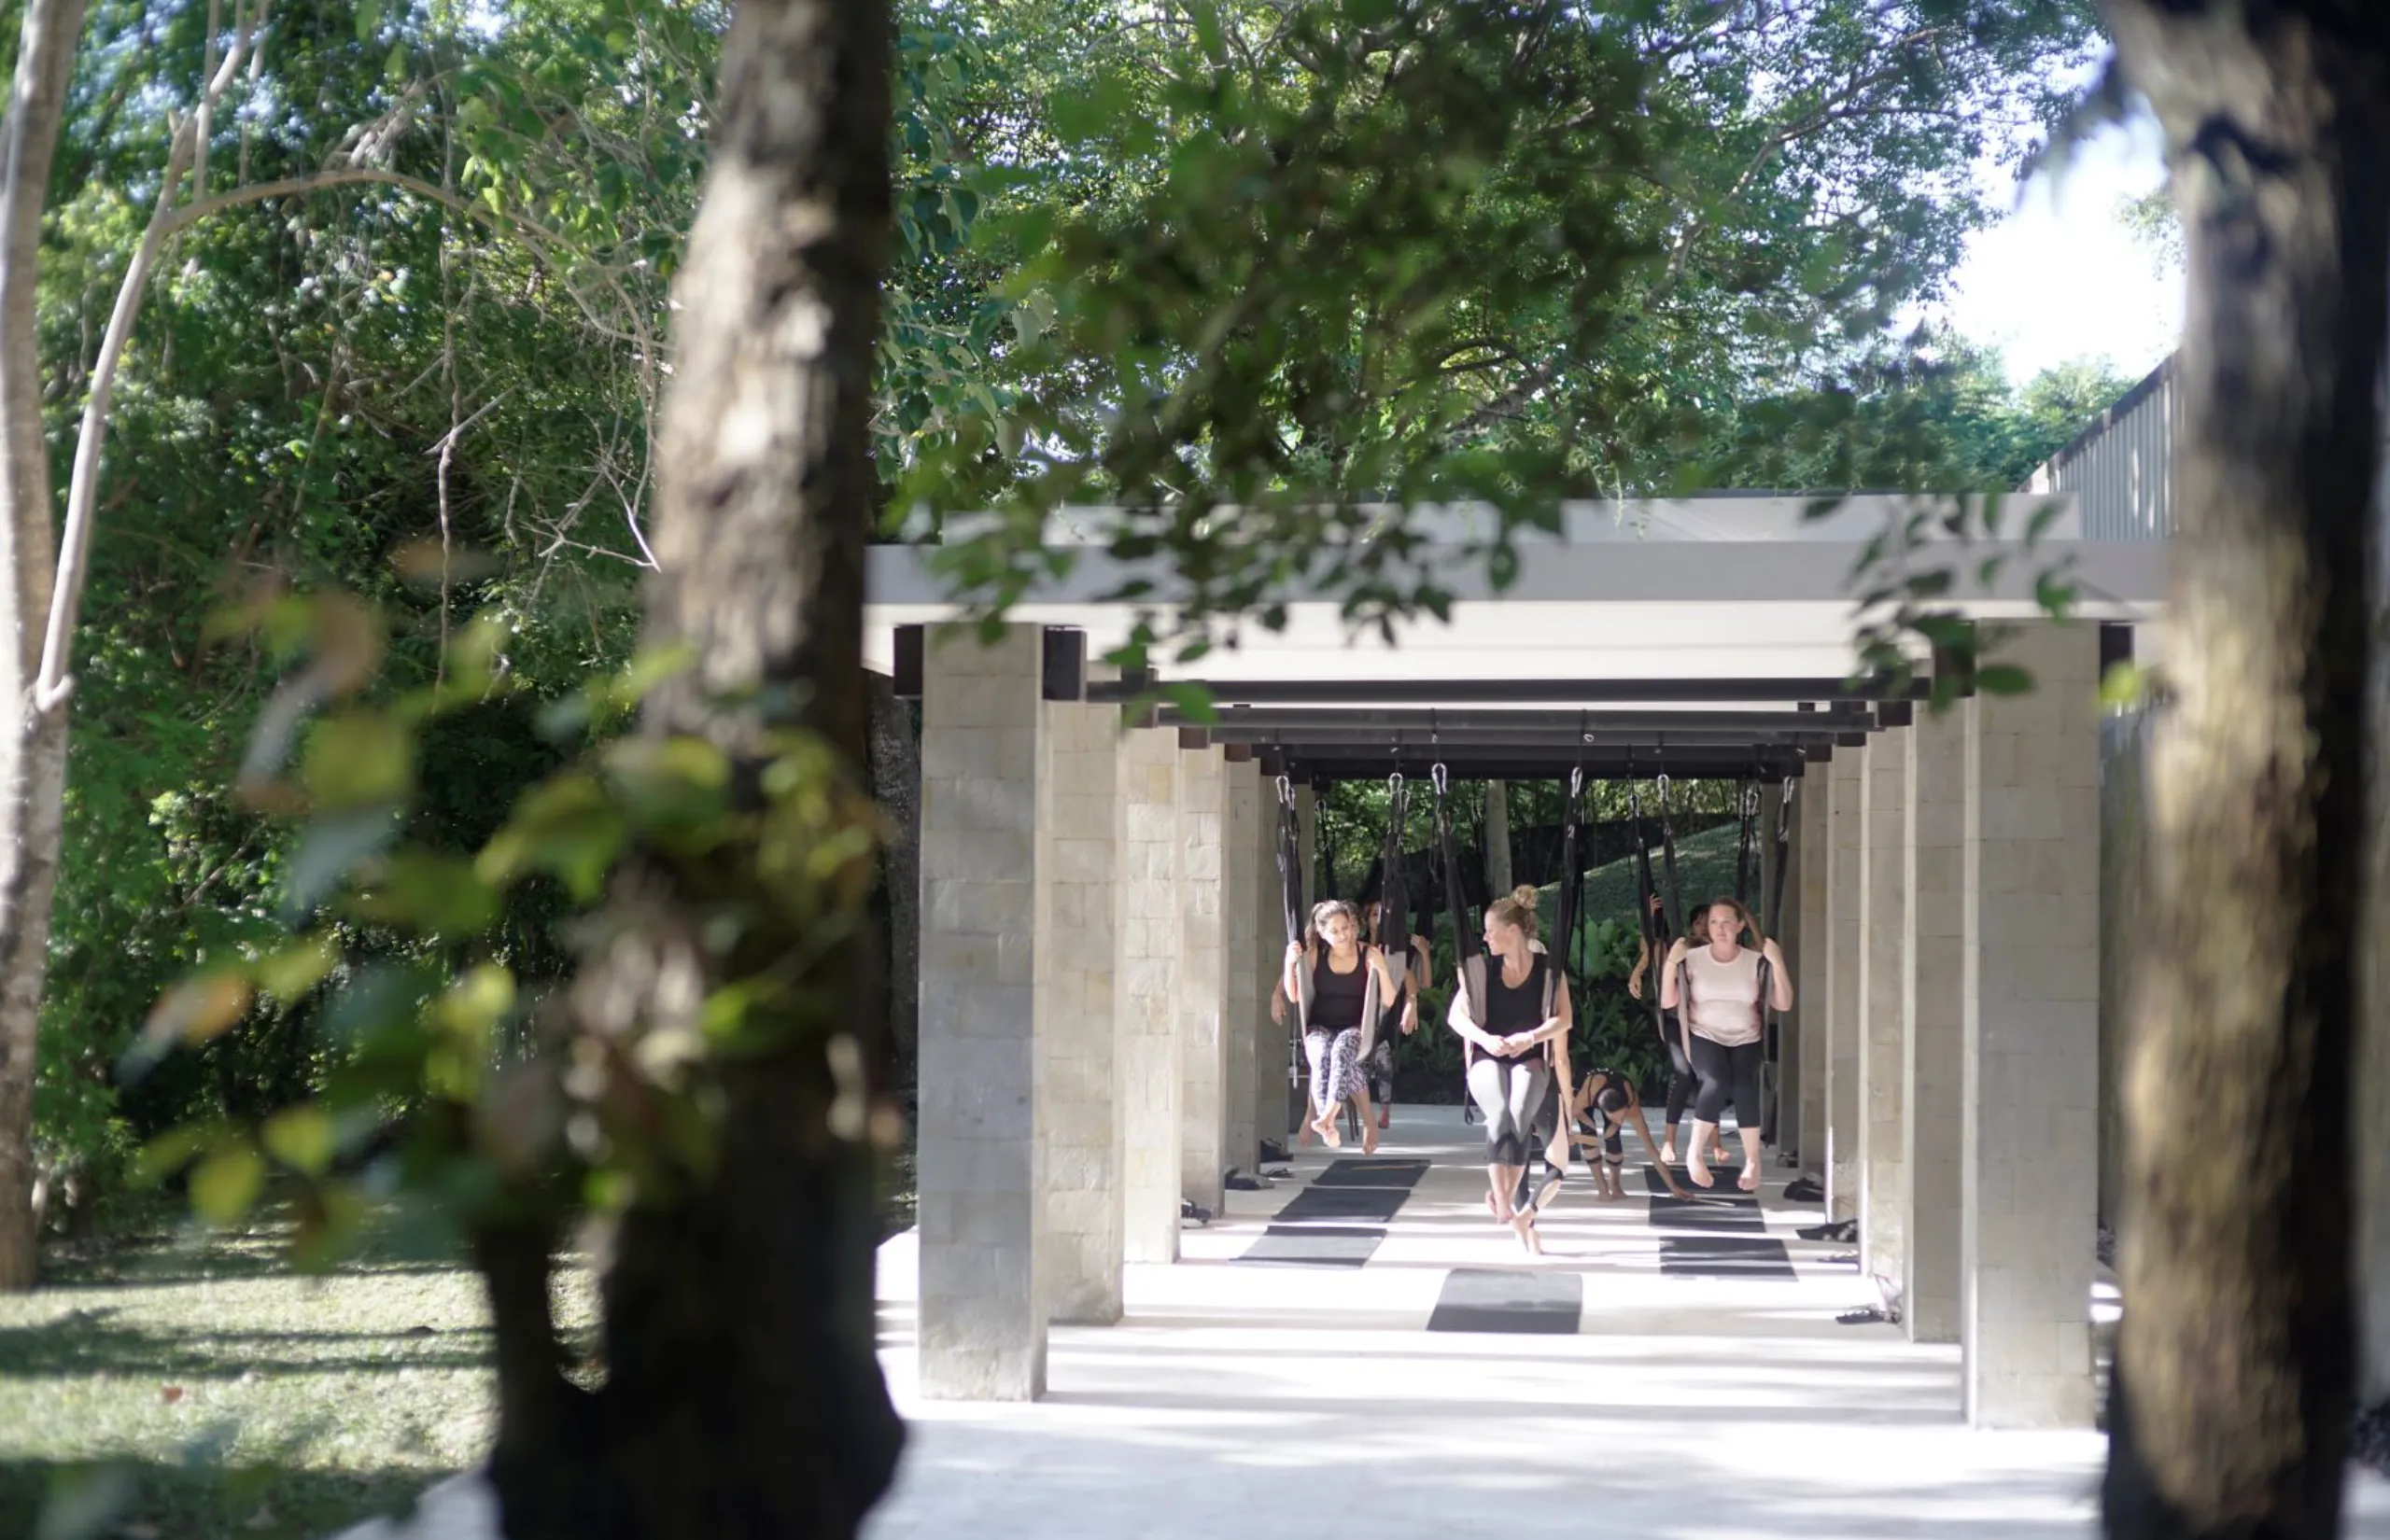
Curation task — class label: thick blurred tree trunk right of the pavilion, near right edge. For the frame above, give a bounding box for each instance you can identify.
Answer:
[2103,0,2390,1540]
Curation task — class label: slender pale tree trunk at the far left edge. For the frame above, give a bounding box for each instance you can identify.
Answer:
[0,0,84,1289]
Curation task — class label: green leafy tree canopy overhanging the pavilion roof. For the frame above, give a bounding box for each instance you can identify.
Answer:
[901,0,2091,664]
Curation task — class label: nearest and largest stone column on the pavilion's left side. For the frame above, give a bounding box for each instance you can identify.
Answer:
[921,625,1047,1402]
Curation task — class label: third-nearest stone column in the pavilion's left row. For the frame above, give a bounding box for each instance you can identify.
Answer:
[1111,728,1178,1263]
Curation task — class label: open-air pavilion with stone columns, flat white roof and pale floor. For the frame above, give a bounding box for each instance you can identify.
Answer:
[841,465,2390,1537]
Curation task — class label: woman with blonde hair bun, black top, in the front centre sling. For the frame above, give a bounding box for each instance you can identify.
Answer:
[1446,889,1575,1256]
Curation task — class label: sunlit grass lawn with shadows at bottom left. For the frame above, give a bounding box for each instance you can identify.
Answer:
[0,1232,593,1540]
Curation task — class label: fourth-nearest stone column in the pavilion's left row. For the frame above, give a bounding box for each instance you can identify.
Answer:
[1178,748,1230,1213]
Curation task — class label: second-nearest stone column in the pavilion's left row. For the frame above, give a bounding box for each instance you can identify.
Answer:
[1037,702,1123,1325]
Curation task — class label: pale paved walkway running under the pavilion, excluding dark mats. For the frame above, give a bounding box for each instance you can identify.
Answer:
[865,1108,2390,1540]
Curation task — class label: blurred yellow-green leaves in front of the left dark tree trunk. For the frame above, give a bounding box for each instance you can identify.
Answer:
[114,597,875,1266]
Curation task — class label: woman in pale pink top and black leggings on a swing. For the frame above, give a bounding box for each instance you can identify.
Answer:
[1659,898,1792,1192]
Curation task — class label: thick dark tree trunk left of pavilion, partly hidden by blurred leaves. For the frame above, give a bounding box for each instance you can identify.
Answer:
[483,0,904,1540]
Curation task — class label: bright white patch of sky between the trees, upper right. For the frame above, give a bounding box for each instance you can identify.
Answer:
[1933,115,2182,385]
